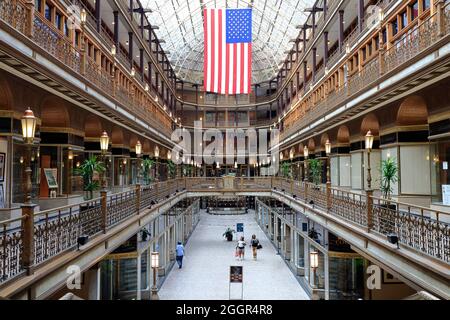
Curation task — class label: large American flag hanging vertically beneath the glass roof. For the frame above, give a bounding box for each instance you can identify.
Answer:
[203,9,252,94]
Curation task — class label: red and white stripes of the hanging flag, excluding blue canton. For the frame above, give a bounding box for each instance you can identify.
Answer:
[203,9,252,94]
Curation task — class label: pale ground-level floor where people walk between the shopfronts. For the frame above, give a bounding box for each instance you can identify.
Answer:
[159,212,309,300]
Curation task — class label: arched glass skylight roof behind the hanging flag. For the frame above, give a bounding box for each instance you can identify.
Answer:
[141,0,315,83]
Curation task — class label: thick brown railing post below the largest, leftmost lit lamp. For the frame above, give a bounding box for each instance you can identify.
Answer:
[22,203,36,275]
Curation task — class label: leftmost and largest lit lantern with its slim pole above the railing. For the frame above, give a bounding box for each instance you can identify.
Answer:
[21,108,37,205]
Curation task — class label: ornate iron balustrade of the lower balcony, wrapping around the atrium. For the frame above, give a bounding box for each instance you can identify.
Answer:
[0,177,450,283]
